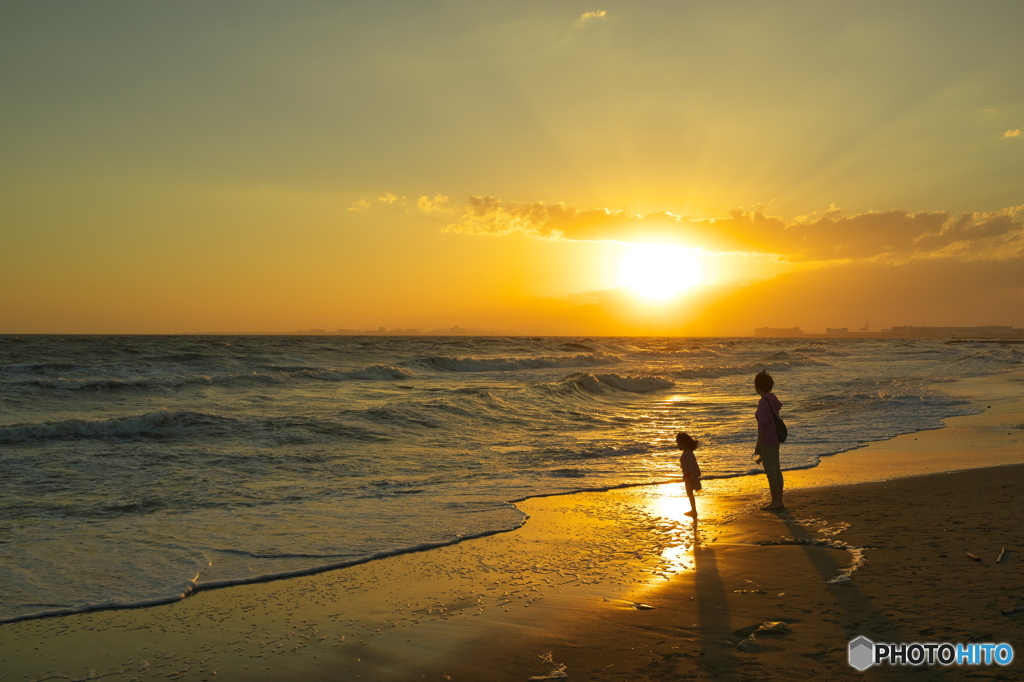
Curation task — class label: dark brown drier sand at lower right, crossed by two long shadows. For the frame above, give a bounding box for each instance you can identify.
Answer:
[423,466,1024,681]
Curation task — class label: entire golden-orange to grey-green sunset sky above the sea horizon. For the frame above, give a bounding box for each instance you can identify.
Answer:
[0,0,1024,335]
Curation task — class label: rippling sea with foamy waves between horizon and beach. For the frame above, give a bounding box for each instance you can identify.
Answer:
[0,336,1024,621]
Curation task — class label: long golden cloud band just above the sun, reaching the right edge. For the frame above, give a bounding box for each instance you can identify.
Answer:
[445,197,1024,262]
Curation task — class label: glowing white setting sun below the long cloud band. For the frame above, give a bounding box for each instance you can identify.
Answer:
[618,244,703,301]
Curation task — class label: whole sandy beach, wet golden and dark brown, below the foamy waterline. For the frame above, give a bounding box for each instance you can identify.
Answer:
[0,375,1024,682]
